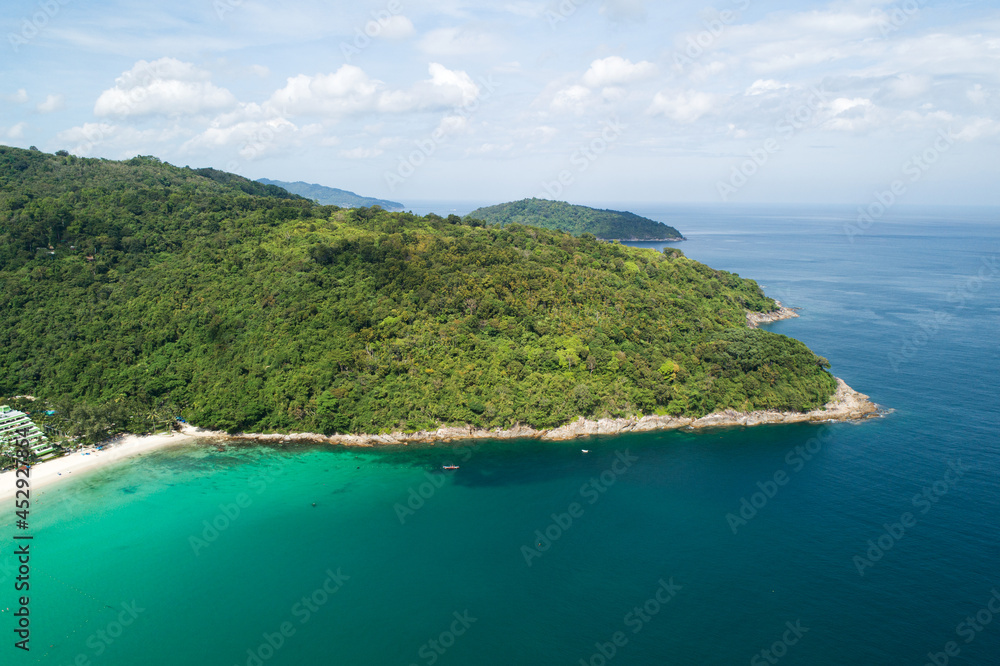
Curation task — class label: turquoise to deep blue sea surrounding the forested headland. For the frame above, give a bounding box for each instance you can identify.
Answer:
[0,207,1000,666]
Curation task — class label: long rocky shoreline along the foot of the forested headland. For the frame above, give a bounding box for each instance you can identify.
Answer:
[201,378,882,446]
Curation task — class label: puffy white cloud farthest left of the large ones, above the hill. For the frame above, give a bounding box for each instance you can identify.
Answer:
[94,58,236,117]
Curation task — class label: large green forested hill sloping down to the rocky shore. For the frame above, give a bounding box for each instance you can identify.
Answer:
[0,147,835,433]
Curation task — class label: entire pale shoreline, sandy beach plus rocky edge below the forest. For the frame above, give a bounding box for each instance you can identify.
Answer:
[0,376,885,501]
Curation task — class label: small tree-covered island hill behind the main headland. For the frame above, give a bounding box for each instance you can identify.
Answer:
[464,198,684,241]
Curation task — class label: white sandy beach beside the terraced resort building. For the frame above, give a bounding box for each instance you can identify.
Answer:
[0,426,217,501]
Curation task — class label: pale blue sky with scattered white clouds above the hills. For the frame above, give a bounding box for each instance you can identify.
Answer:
[0,0,1000,207]
